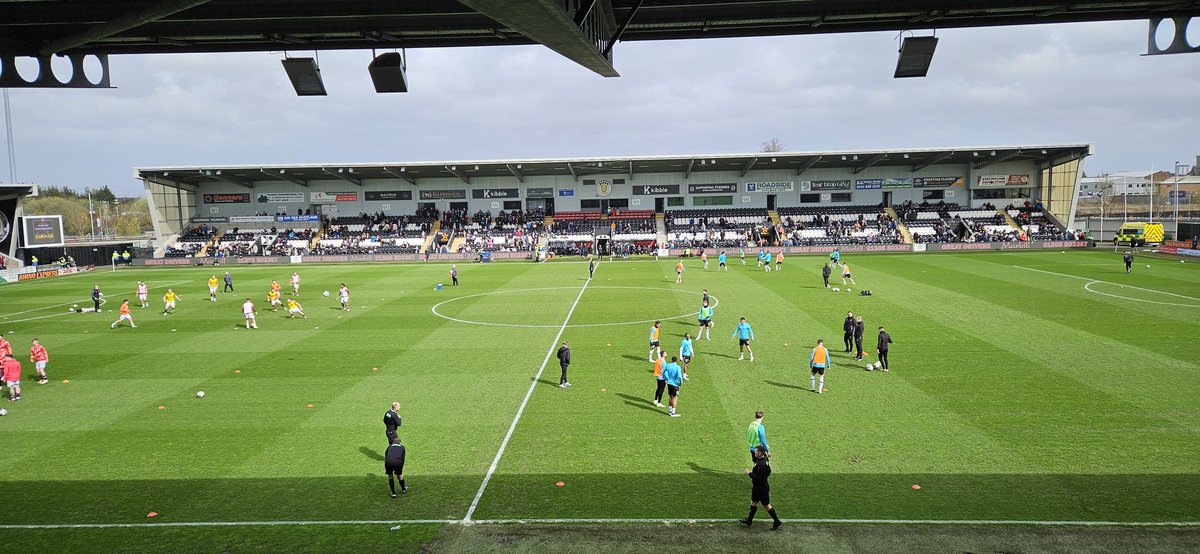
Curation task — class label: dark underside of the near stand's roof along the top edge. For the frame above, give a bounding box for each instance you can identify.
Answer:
[0,0,1200,77]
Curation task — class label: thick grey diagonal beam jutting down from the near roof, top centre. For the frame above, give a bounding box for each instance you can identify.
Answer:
[460,0,620,77]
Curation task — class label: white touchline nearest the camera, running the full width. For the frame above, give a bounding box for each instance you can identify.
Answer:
[0,518,1200,531]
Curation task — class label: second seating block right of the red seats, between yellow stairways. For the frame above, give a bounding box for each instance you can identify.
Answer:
[775,206,901,246]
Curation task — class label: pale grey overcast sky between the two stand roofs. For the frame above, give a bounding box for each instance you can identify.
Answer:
[0,22,1200,195]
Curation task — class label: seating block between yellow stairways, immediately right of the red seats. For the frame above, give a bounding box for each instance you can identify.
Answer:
[666,207,773,248]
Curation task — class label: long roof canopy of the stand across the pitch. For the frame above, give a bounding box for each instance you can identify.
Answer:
[134,144,1092,189]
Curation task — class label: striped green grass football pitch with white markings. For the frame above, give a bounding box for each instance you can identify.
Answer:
[0,251,1200,552]
